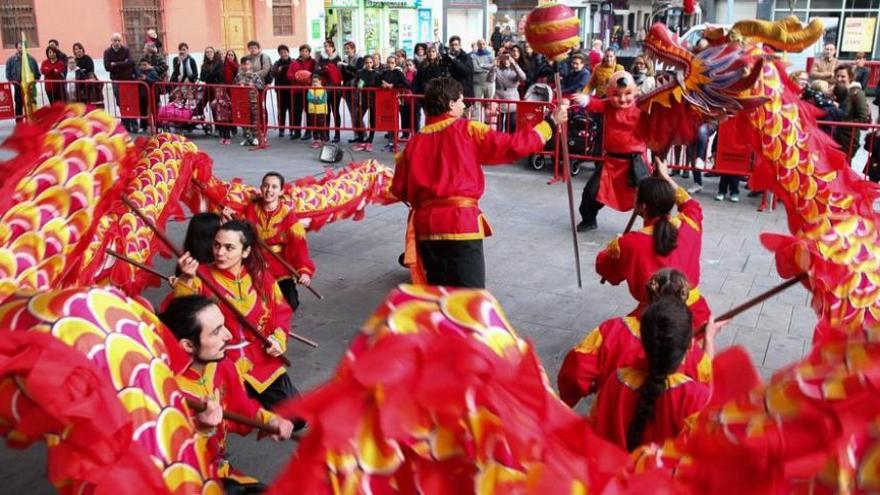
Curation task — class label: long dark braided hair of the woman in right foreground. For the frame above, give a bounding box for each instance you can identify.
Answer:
[626,296,693,451]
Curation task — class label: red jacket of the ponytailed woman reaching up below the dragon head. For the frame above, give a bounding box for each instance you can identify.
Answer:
[596,188,703,305]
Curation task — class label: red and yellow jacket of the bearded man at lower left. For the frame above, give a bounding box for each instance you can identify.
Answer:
[176,359,275,481]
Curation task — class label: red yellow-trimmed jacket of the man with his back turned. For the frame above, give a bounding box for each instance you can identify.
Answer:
[391,115,553,240]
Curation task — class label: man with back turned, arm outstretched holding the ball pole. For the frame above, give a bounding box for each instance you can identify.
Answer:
[391,77,568,288]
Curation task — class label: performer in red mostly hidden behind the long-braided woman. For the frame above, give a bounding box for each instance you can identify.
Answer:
[556,268,714,407]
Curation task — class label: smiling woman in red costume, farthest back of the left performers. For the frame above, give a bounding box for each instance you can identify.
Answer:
[223,172,315,311]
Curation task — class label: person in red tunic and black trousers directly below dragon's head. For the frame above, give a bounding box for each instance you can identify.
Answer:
[573,71,651,232]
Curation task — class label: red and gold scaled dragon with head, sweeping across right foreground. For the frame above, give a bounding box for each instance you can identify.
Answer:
[271,15,880,494]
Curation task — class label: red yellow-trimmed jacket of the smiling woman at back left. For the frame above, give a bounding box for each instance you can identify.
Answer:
[244,201,315,280]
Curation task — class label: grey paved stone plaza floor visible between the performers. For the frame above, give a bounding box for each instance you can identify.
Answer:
[0,125,815,494]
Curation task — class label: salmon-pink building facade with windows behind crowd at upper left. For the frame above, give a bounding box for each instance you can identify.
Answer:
[0,0,312,73]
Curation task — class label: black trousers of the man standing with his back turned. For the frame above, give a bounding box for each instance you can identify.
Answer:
[419,239,486,289]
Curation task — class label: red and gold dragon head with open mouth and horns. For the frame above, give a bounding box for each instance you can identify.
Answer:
[638,18,822,150]
